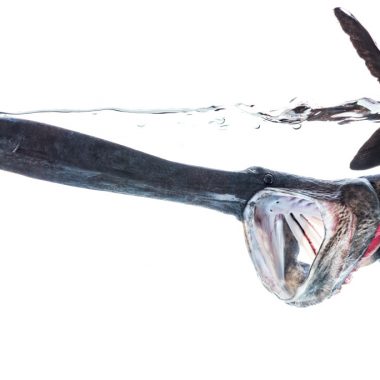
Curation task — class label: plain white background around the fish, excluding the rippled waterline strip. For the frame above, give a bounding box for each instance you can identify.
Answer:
[0,0,380,380]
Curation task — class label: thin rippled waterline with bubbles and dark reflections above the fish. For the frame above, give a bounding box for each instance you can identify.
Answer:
[0,98,380,129]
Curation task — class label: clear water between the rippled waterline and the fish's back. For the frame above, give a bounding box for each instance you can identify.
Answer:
[0,98,380,179]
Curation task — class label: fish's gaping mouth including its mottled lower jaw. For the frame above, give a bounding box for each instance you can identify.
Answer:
[244,188,372,305]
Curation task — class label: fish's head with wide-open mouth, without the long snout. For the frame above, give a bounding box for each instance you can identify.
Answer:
[243,172,380,306]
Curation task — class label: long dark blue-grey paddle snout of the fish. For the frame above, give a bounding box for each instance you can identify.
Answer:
[0,118,264,218]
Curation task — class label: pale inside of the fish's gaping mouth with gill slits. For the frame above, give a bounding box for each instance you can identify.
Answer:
[244,189,328,300]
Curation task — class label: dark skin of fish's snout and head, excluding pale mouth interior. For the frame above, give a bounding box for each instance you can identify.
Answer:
[0,118,380,306]
